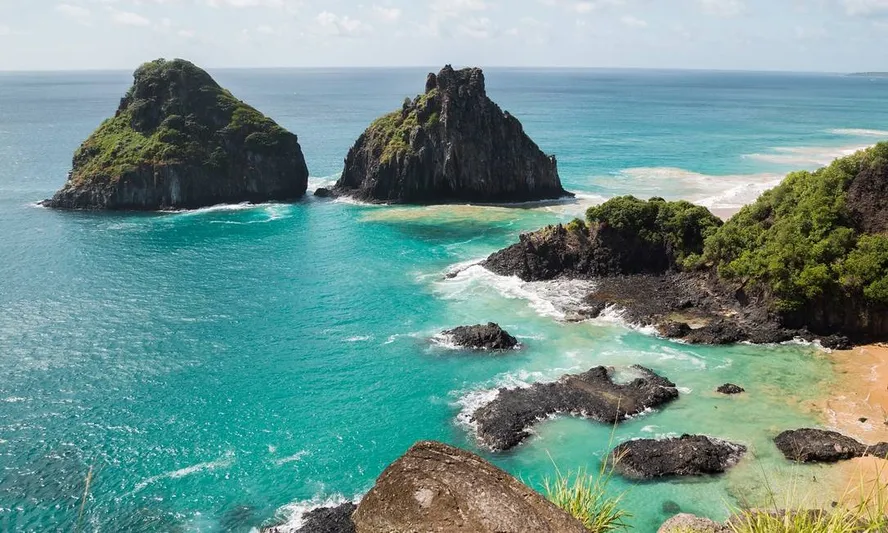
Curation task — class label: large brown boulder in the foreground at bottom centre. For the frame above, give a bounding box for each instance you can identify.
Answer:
[353,442,587,533]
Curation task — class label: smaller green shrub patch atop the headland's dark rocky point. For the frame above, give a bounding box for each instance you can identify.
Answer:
[586,196,722,266]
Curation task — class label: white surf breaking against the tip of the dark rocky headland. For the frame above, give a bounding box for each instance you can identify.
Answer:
[437,261,595,320]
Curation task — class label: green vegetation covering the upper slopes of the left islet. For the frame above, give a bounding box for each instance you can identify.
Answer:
[72,59,294,182]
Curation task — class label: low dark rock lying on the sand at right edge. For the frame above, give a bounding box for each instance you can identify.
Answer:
[774,429,888,463]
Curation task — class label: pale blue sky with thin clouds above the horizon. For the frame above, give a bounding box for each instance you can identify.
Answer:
[0,0,888,72]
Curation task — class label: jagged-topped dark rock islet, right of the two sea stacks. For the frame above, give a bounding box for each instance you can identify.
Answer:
[335,65,570,204]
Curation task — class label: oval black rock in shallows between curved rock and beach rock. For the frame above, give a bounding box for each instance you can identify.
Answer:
[610,435,746,479]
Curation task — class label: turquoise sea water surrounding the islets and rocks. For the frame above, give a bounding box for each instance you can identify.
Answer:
[0,69,888,532]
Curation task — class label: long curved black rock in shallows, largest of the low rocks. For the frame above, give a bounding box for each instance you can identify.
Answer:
[472,366,678,451]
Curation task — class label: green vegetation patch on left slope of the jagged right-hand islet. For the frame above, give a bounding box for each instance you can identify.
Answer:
[366,89,441,163]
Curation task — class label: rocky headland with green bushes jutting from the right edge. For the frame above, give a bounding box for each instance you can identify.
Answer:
[483,143,888,348]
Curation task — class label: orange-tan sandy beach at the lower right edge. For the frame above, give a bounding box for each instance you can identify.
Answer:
[822,344,888,505]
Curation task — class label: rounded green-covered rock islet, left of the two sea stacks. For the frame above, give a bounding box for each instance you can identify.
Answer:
[43,59,308,210]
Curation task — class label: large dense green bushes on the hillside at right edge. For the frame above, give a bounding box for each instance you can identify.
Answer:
[704,143,888,311]
